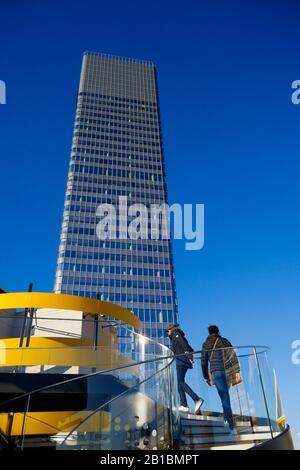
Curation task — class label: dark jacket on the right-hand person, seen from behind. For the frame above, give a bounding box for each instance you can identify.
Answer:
[201,334,240,380]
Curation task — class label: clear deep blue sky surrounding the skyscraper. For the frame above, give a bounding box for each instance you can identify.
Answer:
[0,0,300,444]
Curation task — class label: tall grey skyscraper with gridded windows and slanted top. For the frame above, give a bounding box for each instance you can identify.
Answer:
[54,52,178,341]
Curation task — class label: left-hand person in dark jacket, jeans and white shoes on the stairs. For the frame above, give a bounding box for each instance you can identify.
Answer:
[168,325,203,414]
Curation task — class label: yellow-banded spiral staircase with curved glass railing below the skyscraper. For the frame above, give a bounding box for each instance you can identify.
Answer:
[0,293,293,451]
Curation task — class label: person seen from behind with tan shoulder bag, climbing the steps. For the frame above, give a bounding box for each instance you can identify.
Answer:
[201,325,240,434]
